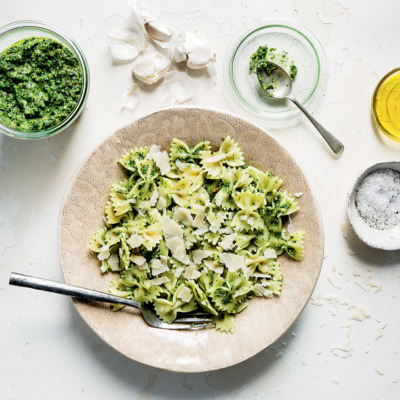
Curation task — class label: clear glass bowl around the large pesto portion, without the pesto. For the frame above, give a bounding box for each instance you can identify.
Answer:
[0,21,90,139]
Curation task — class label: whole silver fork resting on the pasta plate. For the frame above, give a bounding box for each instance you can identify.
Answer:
[9,272,213,331]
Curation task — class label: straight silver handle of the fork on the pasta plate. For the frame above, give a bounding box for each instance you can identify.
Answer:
[9,272,140,309]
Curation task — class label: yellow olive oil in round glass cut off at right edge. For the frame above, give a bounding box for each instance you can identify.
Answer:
[372,68,400,141]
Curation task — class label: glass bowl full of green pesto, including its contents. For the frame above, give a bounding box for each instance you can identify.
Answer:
[0,21,90,139]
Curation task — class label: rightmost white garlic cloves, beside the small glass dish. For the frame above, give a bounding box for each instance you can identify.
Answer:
[174,32,215,69]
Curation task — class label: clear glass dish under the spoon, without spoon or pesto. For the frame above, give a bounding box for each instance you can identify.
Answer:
[224,18,328,126]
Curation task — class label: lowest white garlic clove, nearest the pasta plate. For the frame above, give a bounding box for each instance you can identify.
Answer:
[132,52,171,85]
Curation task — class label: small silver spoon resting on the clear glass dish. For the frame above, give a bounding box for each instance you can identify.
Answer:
[263,61,344,154]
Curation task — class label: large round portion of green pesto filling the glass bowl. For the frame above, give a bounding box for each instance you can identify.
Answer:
[0,37,83,132]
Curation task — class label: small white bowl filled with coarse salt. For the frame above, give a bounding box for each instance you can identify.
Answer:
[347,161,400,250]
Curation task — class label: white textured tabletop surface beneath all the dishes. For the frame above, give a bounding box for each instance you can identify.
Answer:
[0,0,400,400]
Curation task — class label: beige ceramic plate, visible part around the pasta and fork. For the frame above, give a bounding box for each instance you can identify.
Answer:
[59,108,324,372]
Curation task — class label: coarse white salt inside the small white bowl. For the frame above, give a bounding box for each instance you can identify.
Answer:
[355,168,400,230]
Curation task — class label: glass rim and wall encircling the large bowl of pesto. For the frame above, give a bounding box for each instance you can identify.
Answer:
[0,20,90,139]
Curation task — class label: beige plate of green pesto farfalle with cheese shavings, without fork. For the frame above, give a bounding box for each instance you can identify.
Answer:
[59,108,324,372]
